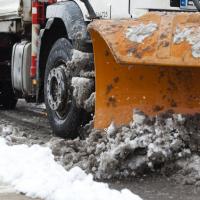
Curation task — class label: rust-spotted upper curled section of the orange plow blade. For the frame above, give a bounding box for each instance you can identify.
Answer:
[89,13,200,67]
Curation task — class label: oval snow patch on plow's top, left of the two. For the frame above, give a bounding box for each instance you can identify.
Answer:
[126,23,158,43]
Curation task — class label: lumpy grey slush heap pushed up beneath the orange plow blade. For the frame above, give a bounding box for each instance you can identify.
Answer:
[48,111,200,179]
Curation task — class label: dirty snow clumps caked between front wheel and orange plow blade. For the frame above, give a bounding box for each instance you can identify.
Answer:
[65,50,95,112]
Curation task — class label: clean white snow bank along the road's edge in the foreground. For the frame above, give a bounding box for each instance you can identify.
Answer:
[0,138,141,200]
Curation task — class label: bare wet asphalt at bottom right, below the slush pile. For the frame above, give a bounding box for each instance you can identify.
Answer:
[110,175,200,200]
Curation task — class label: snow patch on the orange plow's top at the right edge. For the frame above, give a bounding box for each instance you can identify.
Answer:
[174,27,200,58]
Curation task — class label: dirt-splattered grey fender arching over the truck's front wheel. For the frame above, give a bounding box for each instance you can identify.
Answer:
[37,1,92,102]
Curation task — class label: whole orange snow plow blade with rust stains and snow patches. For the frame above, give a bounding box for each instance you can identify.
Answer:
[89,13,200,128]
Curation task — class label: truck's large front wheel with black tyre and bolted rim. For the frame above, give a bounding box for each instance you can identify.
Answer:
[44,38,84,138]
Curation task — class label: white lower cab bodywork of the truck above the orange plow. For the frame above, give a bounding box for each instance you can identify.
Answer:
[76,0,183,19]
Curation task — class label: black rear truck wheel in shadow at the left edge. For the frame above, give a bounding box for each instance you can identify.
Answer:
[0,82,17,110]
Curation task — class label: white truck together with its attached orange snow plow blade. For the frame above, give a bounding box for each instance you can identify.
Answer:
[0,0,200,137]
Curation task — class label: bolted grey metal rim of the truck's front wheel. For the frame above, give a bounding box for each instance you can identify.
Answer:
[47,64,69,119]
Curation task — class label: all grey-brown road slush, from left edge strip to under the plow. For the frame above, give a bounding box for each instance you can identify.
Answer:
[0,107,200,186]
